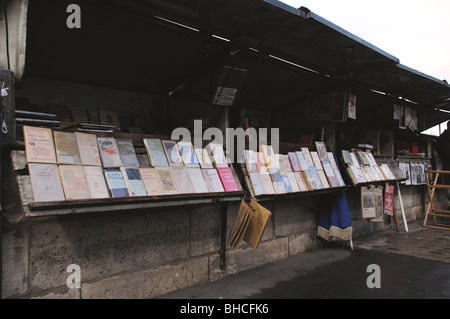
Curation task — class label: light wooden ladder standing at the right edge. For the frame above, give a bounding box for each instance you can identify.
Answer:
[423,170,450,230]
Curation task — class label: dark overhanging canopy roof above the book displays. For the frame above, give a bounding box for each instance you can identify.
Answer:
[26,0,450,128]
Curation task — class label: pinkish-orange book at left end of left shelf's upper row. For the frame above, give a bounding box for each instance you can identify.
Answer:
[23,126,56,164]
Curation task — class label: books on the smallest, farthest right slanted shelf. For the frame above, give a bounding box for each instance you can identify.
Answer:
[342,150,405,185]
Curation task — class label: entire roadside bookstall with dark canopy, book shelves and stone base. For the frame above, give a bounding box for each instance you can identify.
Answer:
[0,0,450,299]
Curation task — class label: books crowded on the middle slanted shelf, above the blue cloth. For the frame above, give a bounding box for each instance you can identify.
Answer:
[244,142,345,196]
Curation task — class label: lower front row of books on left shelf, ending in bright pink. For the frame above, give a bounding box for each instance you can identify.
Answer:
[28,163,239,202]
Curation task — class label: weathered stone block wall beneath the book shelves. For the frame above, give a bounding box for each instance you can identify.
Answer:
[3,180,438,298]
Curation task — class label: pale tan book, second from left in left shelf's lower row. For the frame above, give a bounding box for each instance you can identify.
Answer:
[58,165,91,200]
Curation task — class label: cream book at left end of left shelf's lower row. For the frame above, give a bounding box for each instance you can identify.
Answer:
[28,163,65,202]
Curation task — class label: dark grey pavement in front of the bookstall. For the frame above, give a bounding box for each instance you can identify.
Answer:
[158,221,450,301]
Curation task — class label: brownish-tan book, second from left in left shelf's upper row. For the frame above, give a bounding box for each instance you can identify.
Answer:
[53,131,81,165]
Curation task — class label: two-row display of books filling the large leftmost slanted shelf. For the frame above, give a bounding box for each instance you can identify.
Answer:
[23,126,242,202]
